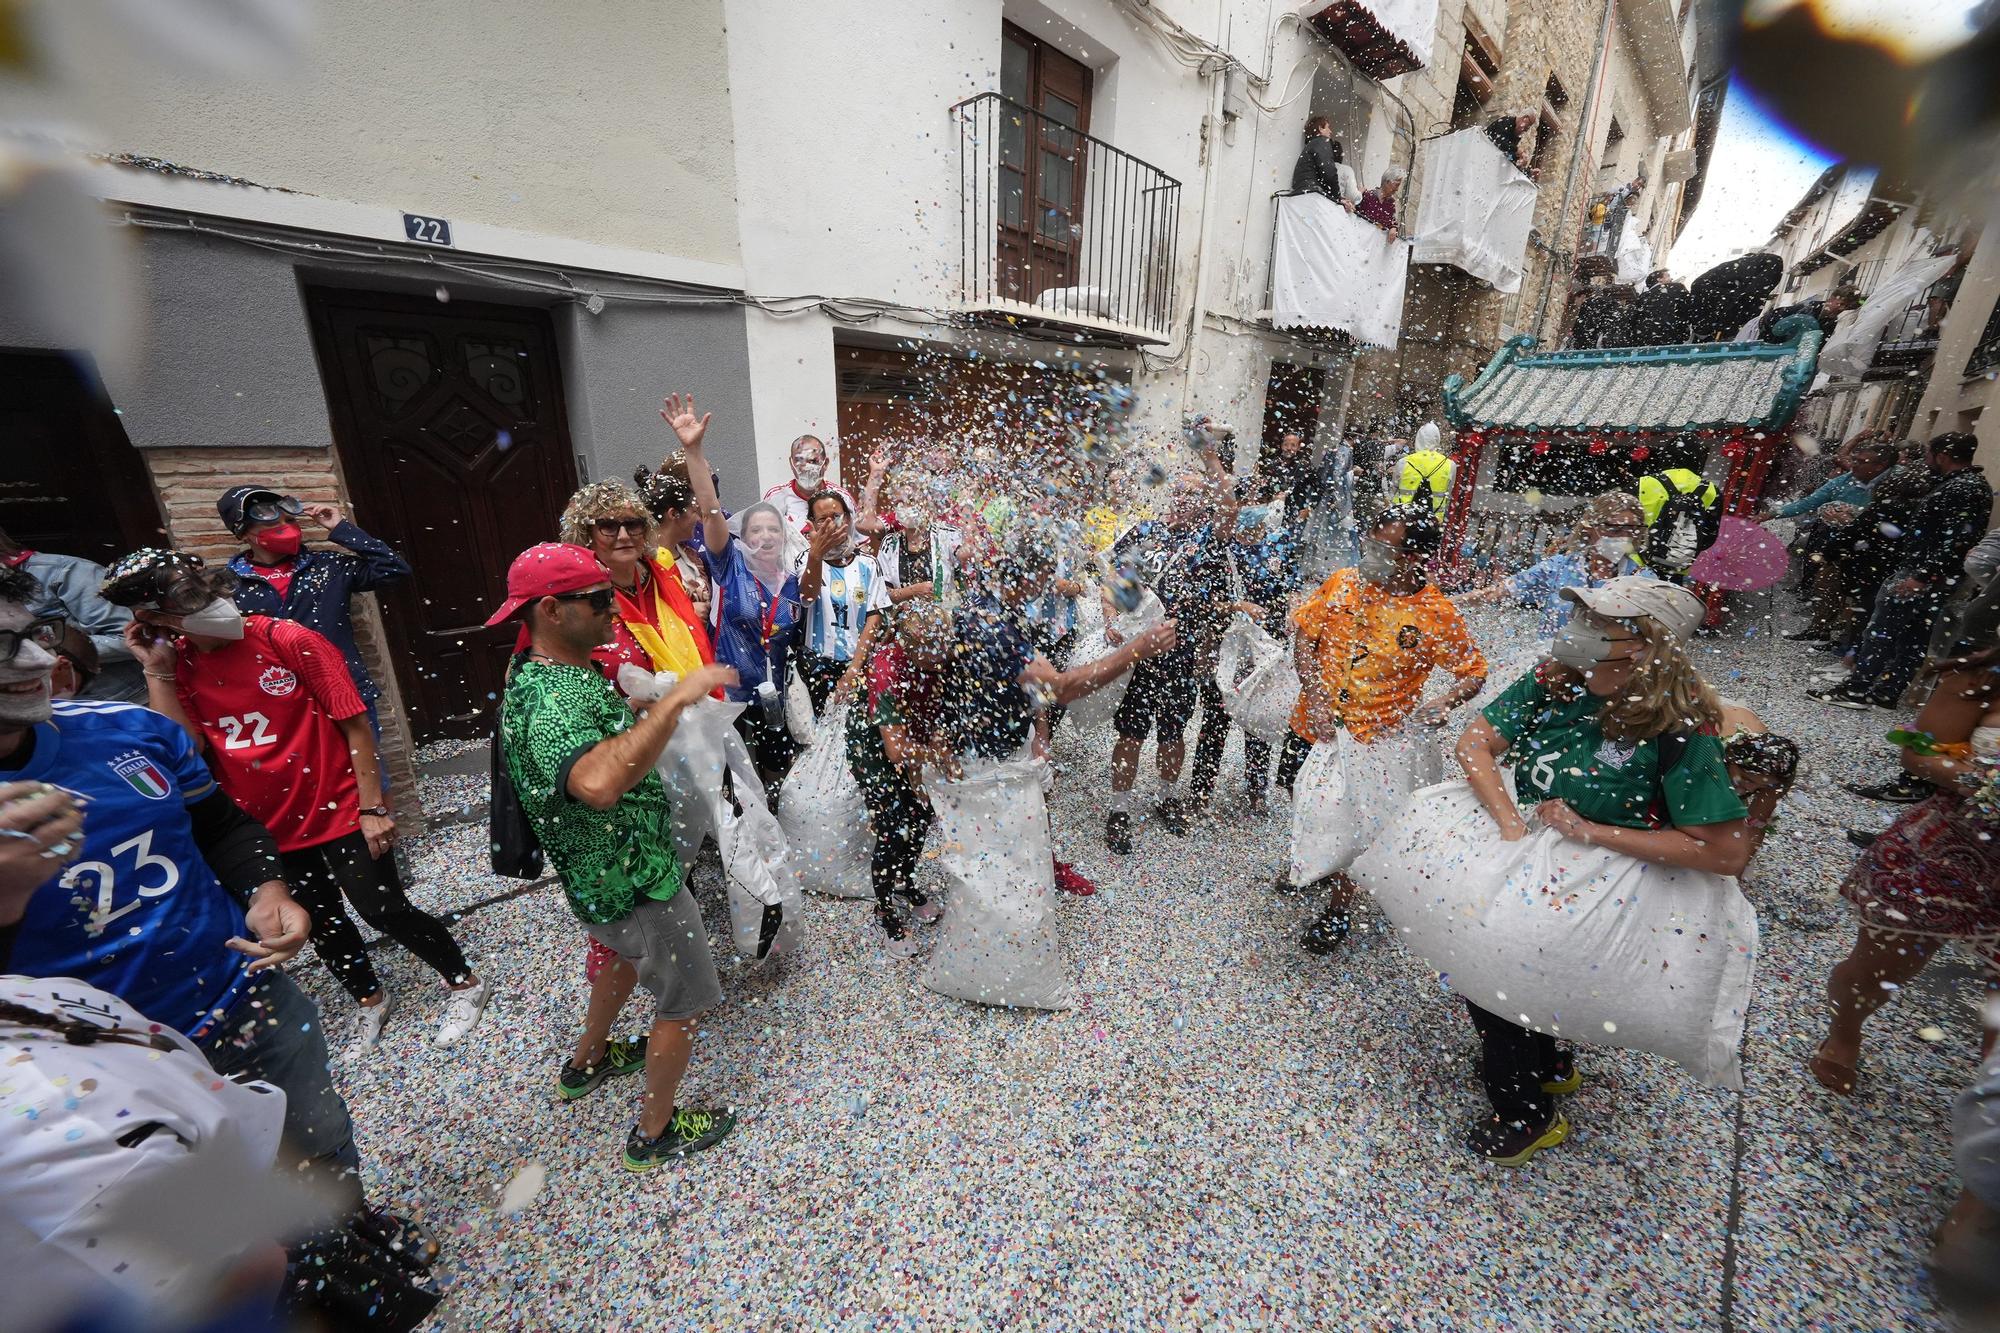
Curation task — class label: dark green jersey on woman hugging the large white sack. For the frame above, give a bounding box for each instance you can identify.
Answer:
[1484,671,1746,829]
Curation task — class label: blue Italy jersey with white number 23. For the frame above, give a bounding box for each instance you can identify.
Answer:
[0,699,250,1037]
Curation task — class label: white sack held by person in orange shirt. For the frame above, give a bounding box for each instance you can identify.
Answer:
[1292,727,1444,887]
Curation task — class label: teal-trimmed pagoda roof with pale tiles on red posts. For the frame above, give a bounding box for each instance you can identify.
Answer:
[1444,314,1826,434]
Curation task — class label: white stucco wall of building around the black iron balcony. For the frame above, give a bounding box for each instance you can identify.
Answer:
[726,0,1388,480]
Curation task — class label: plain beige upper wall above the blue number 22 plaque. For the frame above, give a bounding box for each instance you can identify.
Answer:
[0,0,738,264]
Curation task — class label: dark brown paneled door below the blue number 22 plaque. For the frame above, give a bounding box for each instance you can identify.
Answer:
[308,290,576,741]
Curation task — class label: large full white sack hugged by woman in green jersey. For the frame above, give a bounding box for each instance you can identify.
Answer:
[1354,783,1758,1089]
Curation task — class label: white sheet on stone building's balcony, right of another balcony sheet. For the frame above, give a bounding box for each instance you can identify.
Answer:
[1410,128,1534,292]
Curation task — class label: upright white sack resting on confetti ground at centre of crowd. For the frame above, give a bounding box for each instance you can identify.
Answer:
[924,759,1070,1009]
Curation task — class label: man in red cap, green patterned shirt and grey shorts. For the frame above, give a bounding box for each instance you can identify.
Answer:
[486,542,736,1171]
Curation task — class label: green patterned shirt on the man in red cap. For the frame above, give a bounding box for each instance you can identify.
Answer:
[500,658,680,923]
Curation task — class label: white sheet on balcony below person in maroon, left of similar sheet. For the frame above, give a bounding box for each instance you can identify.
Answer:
[1270,194,1410,346]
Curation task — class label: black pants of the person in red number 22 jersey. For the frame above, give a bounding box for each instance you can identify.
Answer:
[278,831,472,999]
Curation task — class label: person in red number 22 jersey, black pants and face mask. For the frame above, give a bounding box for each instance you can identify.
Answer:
[102,548,490,1047]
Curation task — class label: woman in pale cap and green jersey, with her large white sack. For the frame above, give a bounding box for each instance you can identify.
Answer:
[1356,578,1756,1167]
